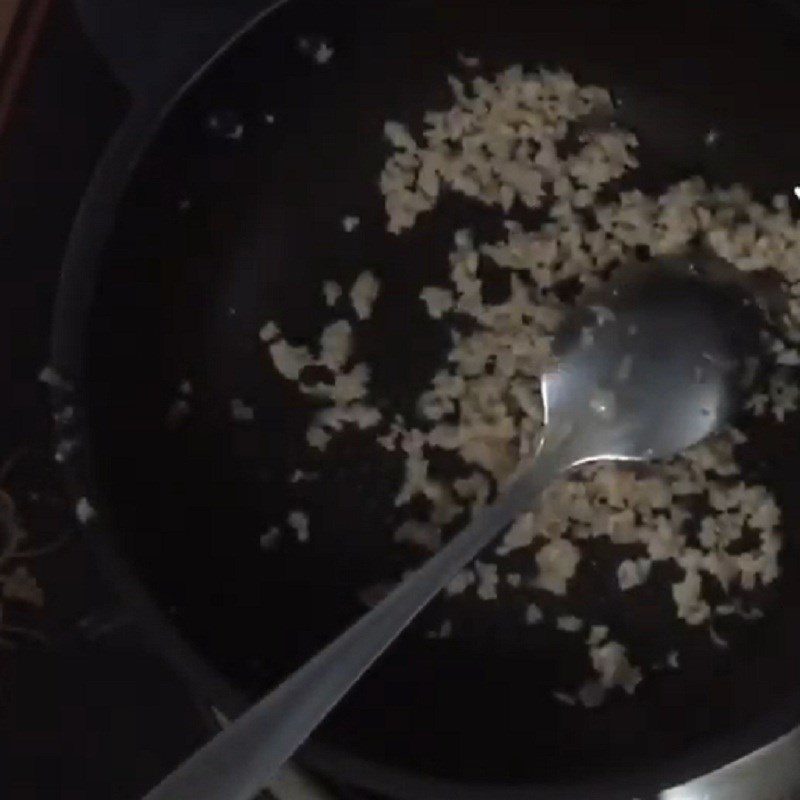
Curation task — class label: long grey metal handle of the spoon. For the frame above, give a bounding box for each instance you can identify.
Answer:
[144,447,565,800]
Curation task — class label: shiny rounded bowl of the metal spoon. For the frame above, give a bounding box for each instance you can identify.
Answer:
[542,255,763,464]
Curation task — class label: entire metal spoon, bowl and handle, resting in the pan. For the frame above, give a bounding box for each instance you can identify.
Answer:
[145,256,760,800]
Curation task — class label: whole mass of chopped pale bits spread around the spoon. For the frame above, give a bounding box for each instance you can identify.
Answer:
[258,62,788,709]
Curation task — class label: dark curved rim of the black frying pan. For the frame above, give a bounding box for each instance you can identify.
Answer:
[50,0,800,800]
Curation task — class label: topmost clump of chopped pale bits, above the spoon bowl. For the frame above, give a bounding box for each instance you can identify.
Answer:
[381,67,636,233]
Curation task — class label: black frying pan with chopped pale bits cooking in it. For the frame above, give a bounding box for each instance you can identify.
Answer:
[53,0,800,800]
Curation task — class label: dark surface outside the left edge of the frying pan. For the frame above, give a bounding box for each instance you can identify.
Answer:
[0,0,211,800]
